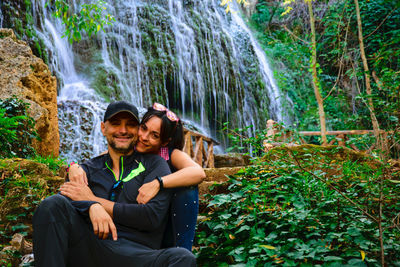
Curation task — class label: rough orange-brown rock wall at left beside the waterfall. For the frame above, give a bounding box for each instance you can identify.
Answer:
[0,29,60,156]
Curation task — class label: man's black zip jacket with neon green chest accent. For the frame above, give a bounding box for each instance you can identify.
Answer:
[72,152,171,249]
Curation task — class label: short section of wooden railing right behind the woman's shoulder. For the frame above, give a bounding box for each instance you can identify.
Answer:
[183,128,219,168]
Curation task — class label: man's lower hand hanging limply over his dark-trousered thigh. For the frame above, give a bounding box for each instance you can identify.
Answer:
[89,203,118,241]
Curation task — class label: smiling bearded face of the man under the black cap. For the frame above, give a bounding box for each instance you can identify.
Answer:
[101,112,139,155]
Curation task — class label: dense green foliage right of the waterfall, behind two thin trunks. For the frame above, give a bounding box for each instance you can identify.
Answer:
[251,0,400,142]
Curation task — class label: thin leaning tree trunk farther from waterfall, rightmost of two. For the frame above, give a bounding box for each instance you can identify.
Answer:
[354,0,382,148]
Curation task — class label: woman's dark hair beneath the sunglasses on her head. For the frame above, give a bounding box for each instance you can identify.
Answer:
[141,107,184,150]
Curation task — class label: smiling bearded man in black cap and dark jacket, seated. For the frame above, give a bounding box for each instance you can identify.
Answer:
[33,101,196,267]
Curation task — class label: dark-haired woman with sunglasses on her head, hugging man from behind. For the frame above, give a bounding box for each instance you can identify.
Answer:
[69,103,205,251]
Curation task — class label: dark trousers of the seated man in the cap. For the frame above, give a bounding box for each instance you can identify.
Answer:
[33,195,196,267]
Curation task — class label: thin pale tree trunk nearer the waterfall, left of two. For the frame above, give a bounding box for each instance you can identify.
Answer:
[305,0,328,146]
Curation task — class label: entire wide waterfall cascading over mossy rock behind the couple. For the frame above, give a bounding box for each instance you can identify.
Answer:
[0,0,290,160]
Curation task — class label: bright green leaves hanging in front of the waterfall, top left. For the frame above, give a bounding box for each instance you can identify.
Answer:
[46,0,115,43]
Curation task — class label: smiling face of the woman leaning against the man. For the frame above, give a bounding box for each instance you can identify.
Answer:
[136,116,161,154]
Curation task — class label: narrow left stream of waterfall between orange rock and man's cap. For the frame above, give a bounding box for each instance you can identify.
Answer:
[29,1,106,161]
